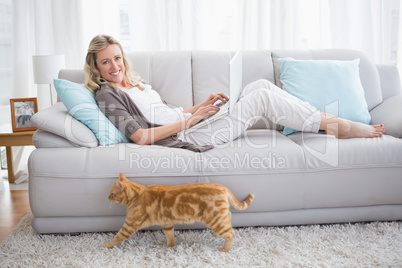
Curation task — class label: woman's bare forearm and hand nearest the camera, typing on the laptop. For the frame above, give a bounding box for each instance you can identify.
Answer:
[130,104,219,145]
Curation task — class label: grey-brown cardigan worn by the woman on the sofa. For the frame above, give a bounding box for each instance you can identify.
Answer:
[95,85,214,152]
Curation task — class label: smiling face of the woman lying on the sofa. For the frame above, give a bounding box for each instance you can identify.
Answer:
[96,44,125,86]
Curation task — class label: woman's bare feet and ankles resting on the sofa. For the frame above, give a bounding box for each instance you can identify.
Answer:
[320,114,385,139]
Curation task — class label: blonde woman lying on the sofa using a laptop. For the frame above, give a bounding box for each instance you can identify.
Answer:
[85,35,385,147]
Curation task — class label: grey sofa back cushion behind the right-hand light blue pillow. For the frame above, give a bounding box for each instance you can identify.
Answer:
[272,49,382,110]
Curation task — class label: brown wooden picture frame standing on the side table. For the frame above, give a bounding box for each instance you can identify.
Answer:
[10,98,38,132]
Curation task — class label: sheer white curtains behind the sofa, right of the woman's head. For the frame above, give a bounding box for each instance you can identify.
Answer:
[121,0,399,64]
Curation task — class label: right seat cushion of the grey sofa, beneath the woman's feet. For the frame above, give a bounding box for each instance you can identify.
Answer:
[287,132,402,171]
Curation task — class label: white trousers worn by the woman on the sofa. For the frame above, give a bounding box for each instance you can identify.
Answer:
[181,80,321,145]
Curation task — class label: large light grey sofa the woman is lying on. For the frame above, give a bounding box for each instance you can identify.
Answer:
[29,50,402,233]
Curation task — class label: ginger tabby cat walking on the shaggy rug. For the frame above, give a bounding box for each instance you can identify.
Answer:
[104,173,254,252]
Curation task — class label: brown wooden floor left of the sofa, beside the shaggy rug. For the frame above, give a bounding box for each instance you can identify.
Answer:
[0,190,30,242]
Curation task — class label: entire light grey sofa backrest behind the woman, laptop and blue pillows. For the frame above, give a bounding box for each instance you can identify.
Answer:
[59,49,382,110]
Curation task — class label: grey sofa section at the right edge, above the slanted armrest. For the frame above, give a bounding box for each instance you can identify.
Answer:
[377,64,402,100]
